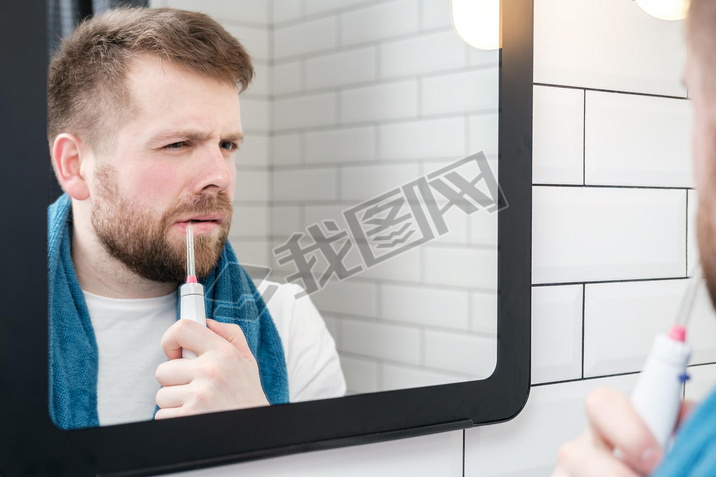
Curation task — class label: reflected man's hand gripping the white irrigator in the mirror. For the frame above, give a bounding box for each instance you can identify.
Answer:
[155,319,269,419]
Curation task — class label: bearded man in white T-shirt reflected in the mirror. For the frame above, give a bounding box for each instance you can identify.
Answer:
[48,9,345,429]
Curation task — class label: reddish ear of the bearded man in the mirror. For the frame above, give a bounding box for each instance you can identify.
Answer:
[52,133,89,200]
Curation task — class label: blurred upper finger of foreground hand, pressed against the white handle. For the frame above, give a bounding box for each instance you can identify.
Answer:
[586,388,662,475]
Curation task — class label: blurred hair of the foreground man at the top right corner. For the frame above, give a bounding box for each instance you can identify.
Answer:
[686,0,716,72]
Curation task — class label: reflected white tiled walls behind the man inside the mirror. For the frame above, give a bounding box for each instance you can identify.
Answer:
[162,0,499,394]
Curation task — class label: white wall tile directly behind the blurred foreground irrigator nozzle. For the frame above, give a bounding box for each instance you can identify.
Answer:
[584,280,716,377]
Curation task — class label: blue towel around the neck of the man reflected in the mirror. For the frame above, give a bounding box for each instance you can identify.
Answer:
[47,194,288,429]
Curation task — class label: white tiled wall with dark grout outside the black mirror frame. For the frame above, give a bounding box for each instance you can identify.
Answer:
[161,0,716,476]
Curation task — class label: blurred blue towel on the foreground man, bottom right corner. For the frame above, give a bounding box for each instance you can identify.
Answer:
[652,384,716,477]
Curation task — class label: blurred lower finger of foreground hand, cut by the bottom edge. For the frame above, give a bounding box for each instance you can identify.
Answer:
[552,434,638,477]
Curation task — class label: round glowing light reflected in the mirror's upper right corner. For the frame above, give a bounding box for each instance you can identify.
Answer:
[451,0,502,50]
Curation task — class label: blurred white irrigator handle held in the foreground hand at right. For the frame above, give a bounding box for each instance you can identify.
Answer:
[631,335,691,449]
